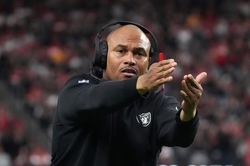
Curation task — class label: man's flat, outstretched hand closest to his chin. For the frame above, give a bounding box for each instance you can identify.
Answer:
[136,59,177,95]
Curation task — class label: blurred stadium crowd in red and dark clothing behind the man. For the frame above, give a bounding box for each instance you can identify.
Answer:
[0,0,250,166]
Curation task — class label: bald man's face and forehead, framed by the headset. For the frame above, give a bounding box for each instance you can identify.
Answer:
[103,25,150,80]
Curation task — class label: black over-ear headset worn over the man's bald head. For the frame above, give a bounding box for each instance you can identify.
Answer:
[93,21,158,75]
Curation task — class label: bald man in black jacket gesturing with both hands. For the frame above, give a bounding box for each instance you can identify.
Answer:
[51,24,206,166]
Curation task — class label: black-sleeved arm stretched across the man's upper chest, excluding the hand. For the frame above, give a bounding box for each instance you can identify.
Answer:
[58,74,141,122]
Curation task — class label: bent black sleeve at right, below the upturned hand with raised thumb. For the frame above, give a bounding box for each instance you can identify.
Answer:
[156,96,199,147]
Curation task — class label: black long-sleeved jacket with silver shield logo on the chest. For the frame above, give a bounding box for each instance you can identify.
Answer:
[51,74,199,166]
